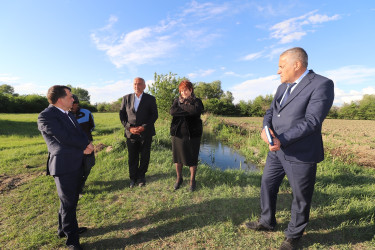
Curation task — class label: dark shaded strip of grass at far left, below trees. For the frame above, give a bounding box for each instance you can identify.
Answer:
[0,120,40,137]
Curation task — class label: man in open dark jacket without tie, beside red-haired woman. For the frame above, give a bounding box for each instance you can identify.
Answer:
[120,77,158,188]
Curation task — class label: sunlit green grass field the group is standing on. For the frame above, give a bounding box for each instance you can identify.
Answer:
[0,113,375,249]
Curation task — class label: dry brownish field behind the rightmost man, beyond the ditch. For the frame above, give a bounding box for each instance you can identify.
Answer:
[221,117,375,168]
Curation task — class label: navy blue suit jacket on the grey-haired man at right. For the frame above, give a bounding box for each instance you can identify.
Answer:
[263,70,334,163]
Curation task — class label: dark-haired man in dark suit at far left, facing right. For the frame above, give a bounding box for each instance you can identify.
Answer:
[38,85,94,249]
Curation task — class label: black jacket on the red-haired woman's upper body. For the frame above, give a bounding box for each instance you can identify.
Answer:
[169,98,204,138]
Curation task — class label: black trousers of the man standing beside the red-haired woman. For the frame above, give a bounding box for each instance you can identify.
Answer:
[126,136,152,181]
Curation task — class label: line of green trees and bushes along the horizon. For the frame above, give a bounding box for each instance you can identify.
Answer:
[0,73,375,120]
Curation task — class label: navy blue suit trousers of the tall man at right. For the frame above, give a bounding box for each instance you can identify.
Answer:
[260,150,317,238]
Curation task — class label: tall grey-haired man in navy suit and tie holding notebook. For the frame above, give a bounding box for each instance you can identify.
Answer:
[246,48,334,249]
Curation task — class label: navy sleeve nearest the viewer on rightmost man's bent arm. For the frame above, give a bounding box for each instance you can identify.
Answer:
[278,79,334,147]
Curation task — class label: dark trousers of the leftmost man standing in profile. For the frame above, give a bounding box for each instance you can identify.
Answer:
[54,169,82,245]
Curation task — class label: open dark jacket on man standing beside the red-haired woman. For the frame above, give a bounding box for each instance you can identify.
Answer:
[120,93,158,139]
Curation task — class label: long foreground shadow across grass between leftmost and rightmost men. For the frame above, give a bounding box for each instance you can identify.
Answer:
[84,198,258,249]
